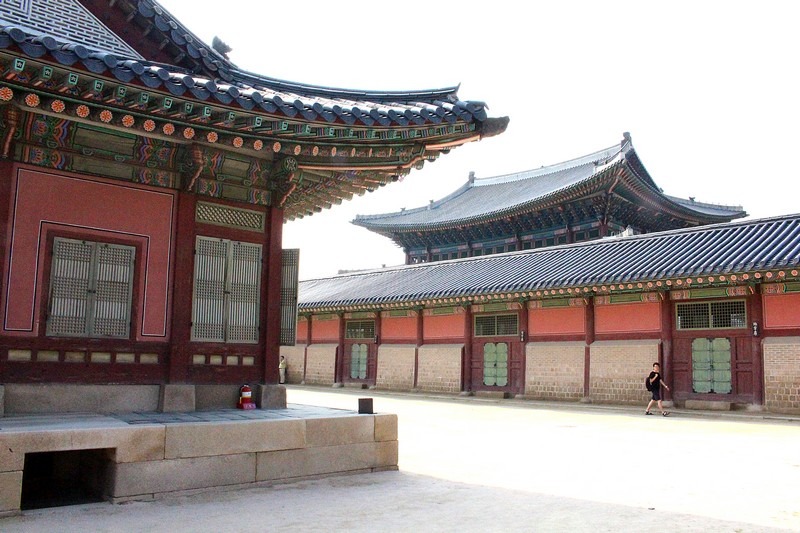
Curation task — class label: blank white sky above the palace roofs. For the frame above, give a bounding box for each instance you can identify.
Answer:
[159,0,800,279]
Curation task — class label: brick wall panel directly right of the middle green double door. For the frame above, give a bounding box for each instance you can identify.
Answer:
[525,342,586,400]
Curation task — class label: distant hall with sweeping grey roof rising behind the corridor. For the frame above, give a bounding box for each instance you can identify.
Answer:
[353,133,746,264]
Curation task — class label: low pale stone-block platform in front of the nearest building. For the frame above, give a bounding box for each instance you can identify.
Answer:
[0,406,398,515]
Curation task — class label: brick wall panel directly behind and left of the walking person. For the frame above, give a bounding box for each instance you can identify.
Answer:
[589,340,660,405]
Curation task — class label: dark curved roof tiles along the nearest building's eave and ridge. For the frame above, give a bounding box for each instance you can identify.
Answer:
[0,0,488,126]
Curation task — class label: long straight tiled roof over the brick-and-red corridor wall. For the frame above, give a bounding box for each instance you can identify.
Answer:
[299,215,800,310]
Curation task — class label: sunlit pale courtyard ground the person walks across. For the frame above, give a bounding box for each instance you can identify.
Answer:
[0,387,800,532]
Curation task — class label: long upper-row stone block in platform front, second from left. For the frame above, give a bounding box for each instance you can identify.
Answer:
[165,420,305,459]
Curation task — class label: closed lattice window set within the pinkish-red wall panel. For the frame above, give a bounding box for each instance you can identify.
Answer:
[47,237,136,339]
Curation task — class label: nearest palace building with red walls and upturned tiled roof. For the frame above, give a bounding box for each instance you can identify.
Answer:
[0,0,508,412]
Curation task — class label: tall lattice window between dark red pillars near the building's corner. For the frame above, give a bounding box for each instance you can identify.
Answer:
[192,237,261,344]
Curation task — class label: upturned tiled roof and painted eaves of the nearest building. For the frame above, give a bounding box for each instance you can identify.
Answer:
[0,0,508,220]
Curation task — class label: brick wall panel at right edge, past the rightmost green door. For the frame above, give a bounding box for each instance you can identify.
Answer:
[762,337,800,414]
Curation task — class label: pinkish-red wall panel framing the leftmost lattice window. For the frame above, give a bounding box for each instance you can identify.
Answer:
[0,166,175,341]
